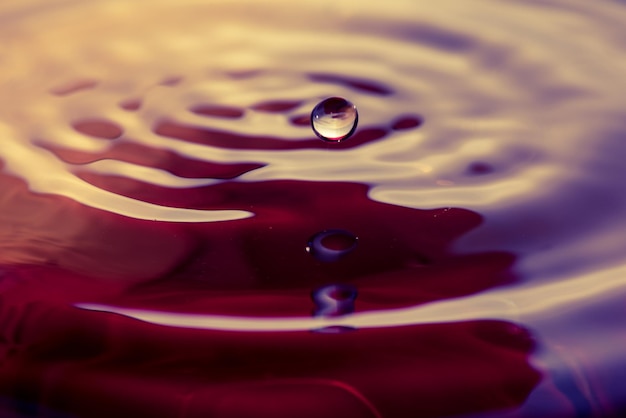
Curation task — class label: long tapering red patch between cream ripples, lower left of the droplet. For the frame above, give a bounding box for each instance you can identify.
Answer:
[39,141,265,179]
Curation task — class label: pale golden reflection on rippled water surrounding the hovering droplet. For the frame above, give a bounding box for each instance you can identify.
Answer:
[0,0,626,221]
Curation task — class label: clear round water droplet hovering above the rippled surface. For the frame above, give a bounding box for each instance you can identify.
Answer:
[311,97,359,142]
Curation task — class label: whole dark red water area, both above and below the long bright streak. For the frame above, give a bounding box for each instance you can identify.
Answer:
[0,169,540,418]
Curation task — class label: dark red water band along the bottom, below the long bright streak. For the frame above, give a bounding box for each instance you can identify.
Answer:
[0,288,541,418]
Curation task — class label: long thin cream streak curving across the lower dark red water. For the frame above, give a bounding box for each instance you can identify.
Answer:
[76,260,626,332]
